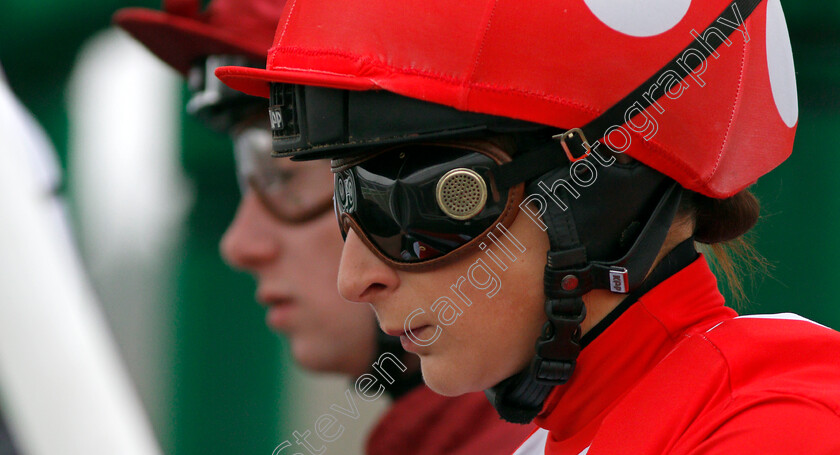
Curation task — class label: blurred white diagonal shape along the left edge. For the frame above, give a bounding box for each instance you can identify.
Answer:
[0,62,161,455]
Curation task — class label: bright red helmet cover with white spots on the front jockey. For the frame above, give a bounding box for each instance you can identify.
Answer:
[216,0,798,198]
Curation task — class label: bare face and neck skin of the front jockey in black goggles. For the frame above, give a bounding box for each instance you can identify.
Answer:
[338,191,693,396]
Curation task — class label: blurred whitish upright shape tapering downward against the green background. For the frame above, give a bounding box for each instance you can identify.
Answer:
[67,28,193,445]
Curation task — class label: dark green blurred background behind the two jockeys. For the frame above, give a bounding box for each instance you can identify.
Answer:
[0,0,840,455]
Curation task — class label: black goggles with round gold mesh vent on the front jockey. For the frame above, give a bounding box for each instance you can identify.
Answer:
[333,140,524,269]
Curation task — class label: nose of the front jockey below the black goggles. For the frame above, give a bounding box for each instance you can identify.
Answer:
[338,229,400,304]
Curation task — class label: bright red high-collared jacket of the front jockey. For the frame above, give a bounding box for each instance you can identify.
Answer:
[516,257,840,455]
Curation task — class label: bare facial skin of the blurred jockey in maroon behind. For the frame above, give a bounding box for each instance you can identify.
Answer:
[220,160,376,377]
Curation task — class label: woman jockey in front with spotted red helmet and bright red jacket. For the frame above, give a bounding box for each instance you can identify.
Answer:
[216,0,840,455]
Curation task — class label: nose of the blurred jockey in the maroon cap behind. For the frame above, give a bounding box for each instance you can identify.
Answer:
[219,192,280,270]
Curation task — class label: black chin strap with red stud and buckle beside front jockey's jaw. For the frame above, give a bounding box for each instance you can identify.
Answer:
[485,183,682,423]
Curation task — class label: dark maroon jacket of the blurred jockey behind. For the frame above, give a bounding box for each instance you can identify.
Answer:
[365,385,535,455]
